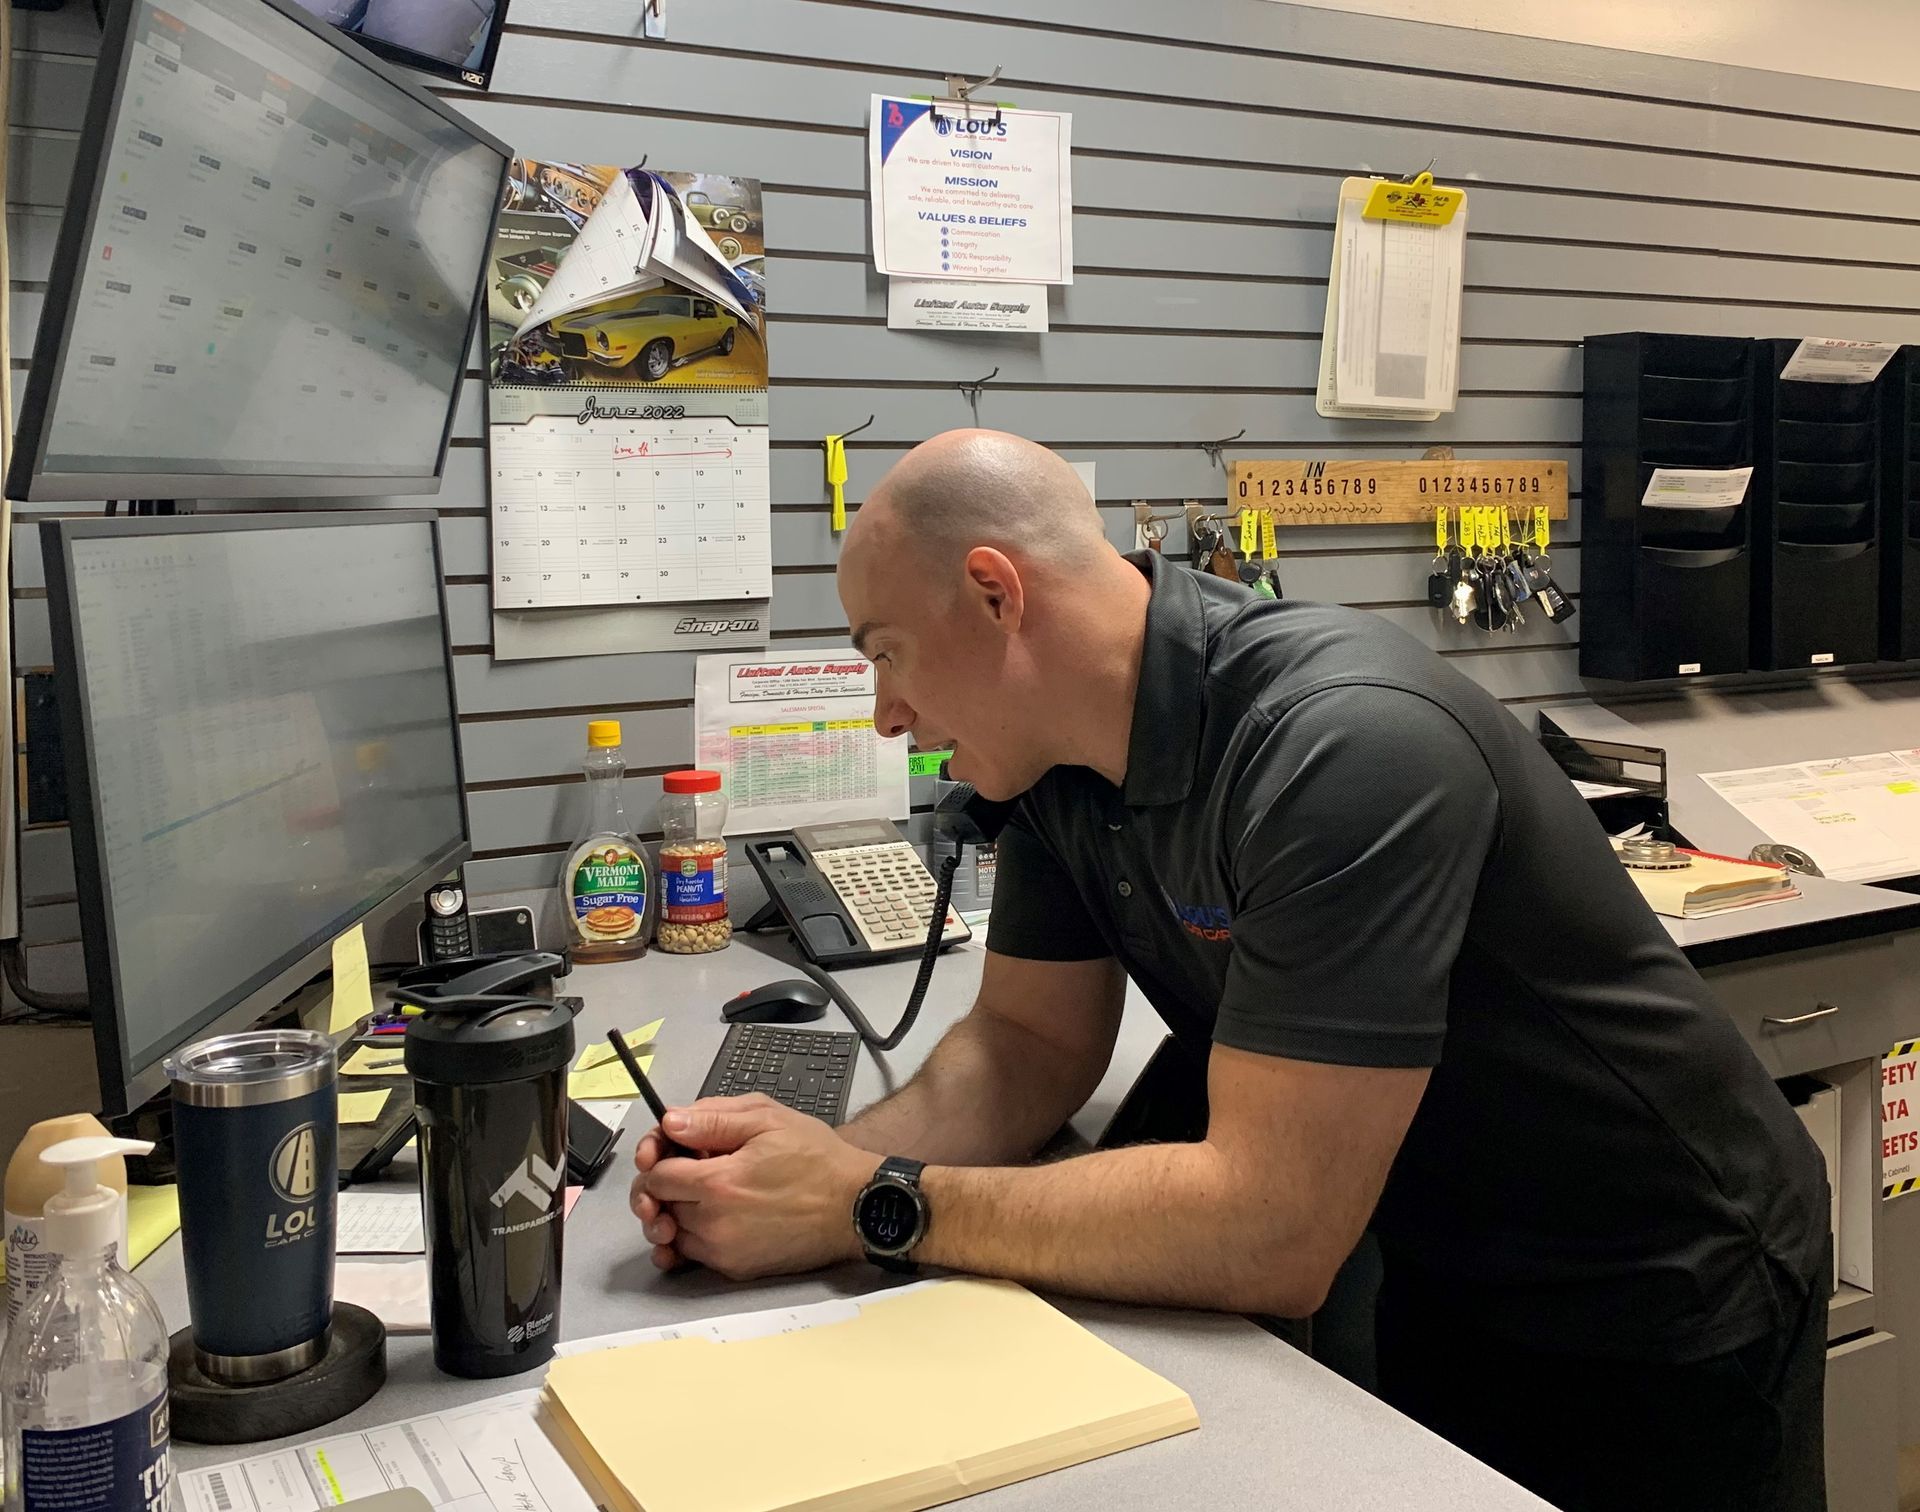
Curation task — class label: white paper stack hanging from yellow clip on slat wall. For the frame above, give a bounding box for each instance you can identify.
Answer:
[1315,178,1467,420]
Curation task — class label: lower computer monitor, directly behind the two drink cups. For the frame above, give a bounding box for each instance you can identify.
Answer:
[40,510,470,1113]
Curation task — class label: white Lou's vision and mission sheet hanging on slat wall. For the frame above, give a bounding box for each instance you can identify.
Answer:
[866,94,1073,284]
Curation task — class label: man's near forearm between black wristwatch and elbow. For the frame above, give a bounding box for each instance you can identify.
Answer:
[914,1144,1340,1316]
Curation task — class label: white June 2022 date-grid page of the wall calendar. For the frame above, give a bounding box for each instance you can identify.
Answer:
[492,416,774,608]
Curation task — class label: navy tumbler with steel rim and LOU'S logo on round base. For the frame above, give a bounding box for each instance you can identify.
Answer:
[167,1028,338,1385]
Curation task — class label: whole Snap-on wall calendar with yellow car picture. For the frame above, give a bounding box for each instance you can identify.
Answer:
[488,157,774,656]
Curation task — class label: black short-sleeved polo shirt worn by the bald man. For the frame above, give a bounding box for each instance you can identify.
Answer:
[989,553,1828,1362]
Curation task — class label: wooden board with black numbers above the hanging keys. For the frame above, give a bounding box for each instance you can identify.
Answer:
[1227,457,1567,526]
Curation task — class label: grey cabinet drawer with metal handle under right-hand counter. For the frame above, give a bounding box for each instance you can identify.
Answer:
[1701,931,1920,1076]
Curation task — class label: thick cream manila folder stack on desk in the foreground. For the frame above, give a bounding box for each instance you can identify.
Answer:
[541,1278,1200,1512]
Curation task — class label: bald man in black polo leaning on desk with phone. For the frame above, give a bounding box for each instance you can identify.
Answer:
[634,432,1830,1512]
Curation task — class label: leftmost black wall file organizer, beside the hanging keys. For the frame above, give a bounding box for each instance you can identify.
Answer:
[1580,332,1755,681]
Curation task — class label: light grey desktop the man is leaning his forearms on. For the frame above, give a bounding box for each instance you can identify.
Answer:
[138,940,1546,1512]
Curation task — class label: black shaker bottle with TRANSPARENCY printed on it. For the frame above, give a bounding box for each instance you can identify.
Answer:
[407,992,574,1376]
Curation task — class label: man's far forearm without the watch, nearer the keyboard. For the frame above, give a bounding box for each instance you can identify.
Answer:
[841,1009,1104,1167]
